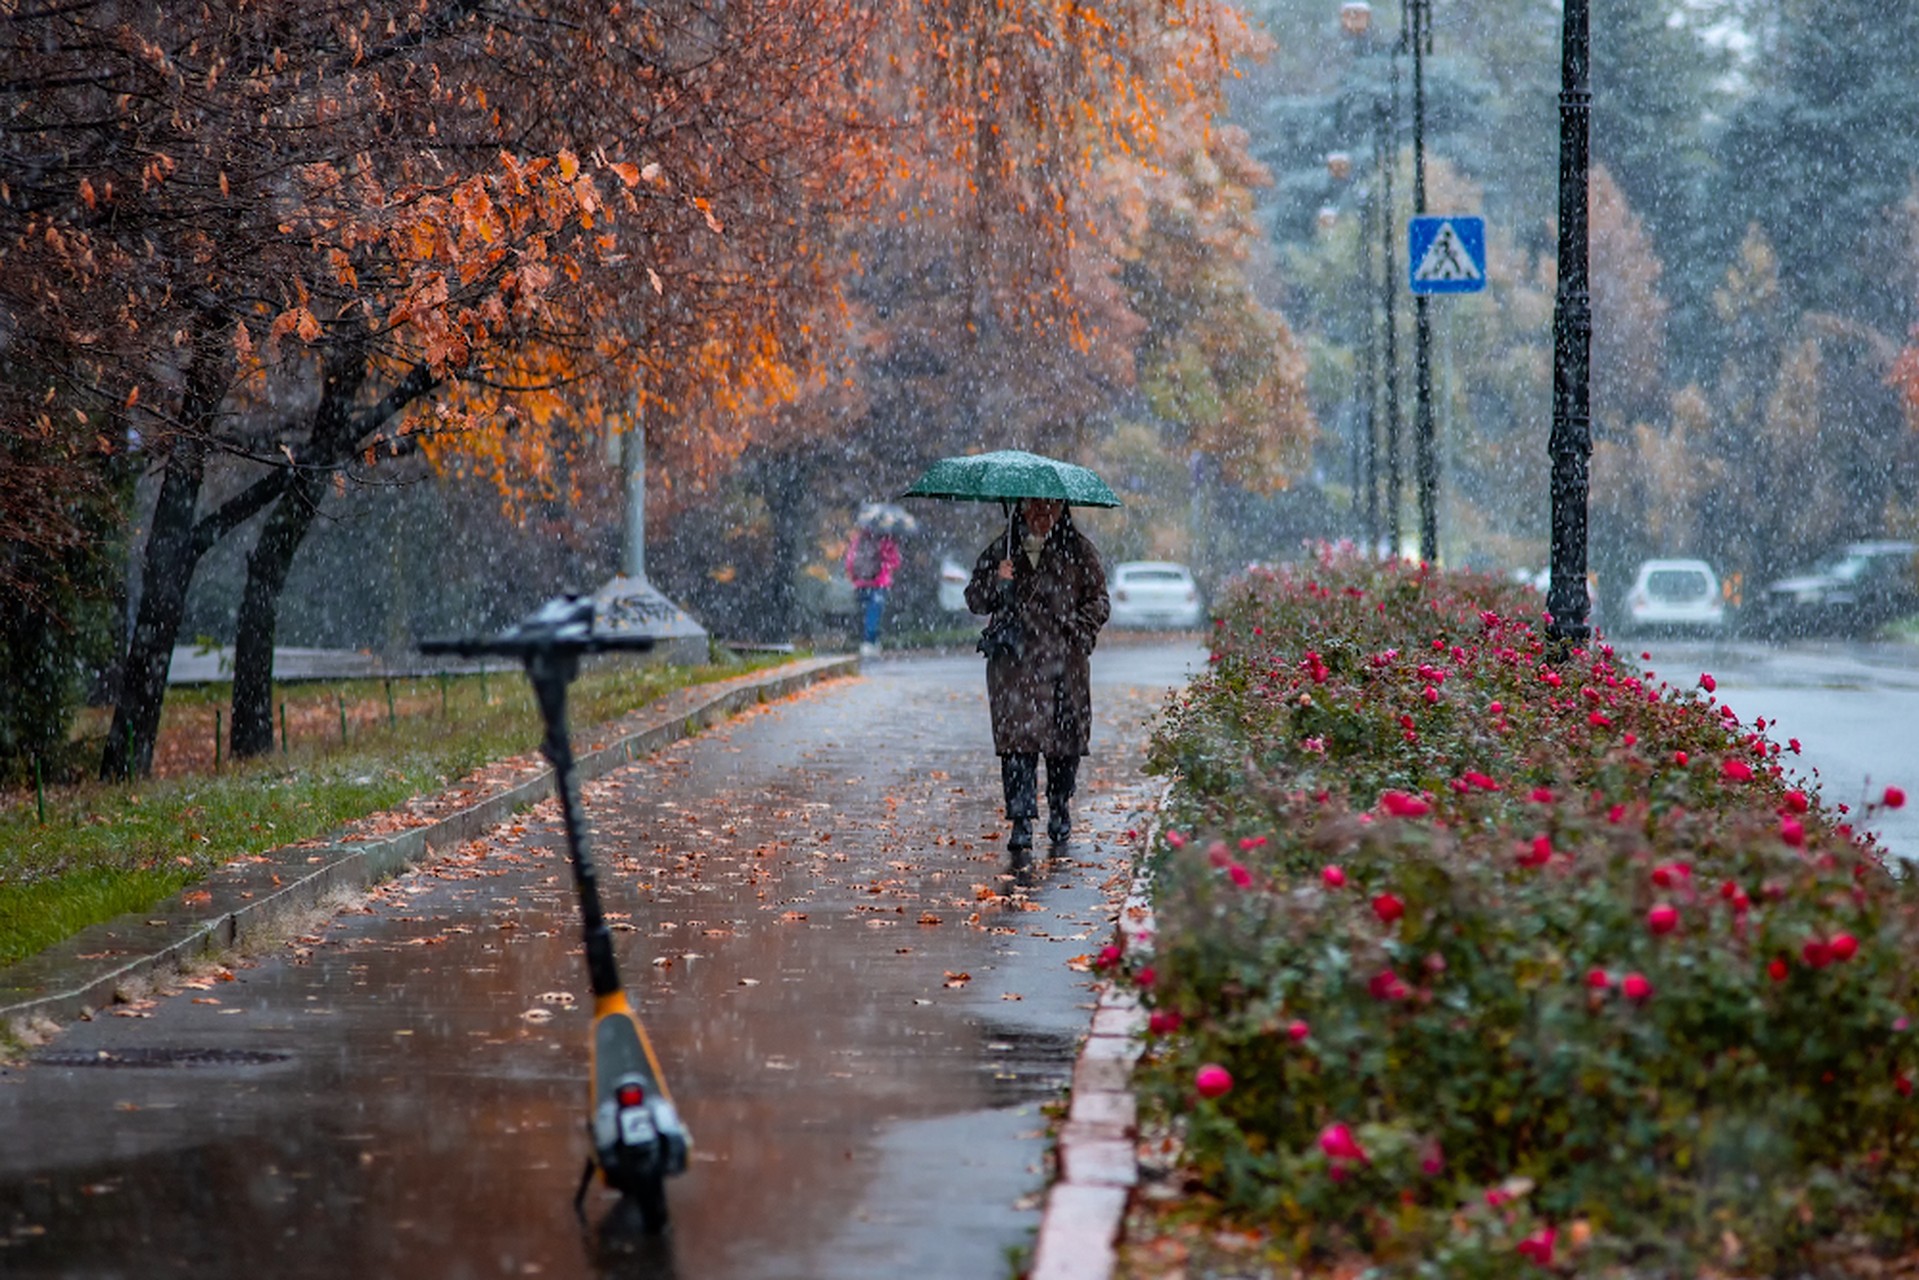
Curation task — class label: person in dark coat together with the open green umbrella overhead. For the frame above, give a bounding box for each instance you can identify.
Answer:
[906,449,1119,858]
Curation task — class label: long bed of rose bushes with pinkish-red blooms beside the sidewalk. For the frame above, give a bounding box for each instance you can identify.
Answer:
[1115,555,1919,1276]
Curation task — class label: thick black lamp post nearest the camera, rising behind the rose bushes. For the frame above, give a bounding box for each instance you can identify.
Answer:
[1547,0,1593,649]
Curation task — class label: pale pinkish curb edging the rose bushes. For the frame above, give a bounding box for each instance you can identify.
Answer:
[1027,785,1171,1280]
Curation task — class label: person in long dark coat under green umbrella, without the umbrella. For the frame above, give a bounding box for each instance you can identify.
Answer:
[965,497,1111,854]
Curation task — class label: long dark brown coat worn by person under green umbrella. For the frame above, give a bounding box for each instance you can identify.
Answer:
[965,514,1113,756]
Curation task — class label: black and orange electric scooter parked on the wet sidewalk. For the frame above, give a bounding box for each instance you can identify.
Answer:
[420,595,691,1232]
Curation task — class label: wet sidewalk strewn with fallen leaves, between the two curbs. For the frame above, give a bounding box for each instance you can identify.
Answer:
[0,645,1199,1280]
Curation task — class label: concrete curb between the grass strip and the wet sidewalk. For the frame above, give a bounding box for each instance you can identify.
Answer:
[0,656,860,1025]
